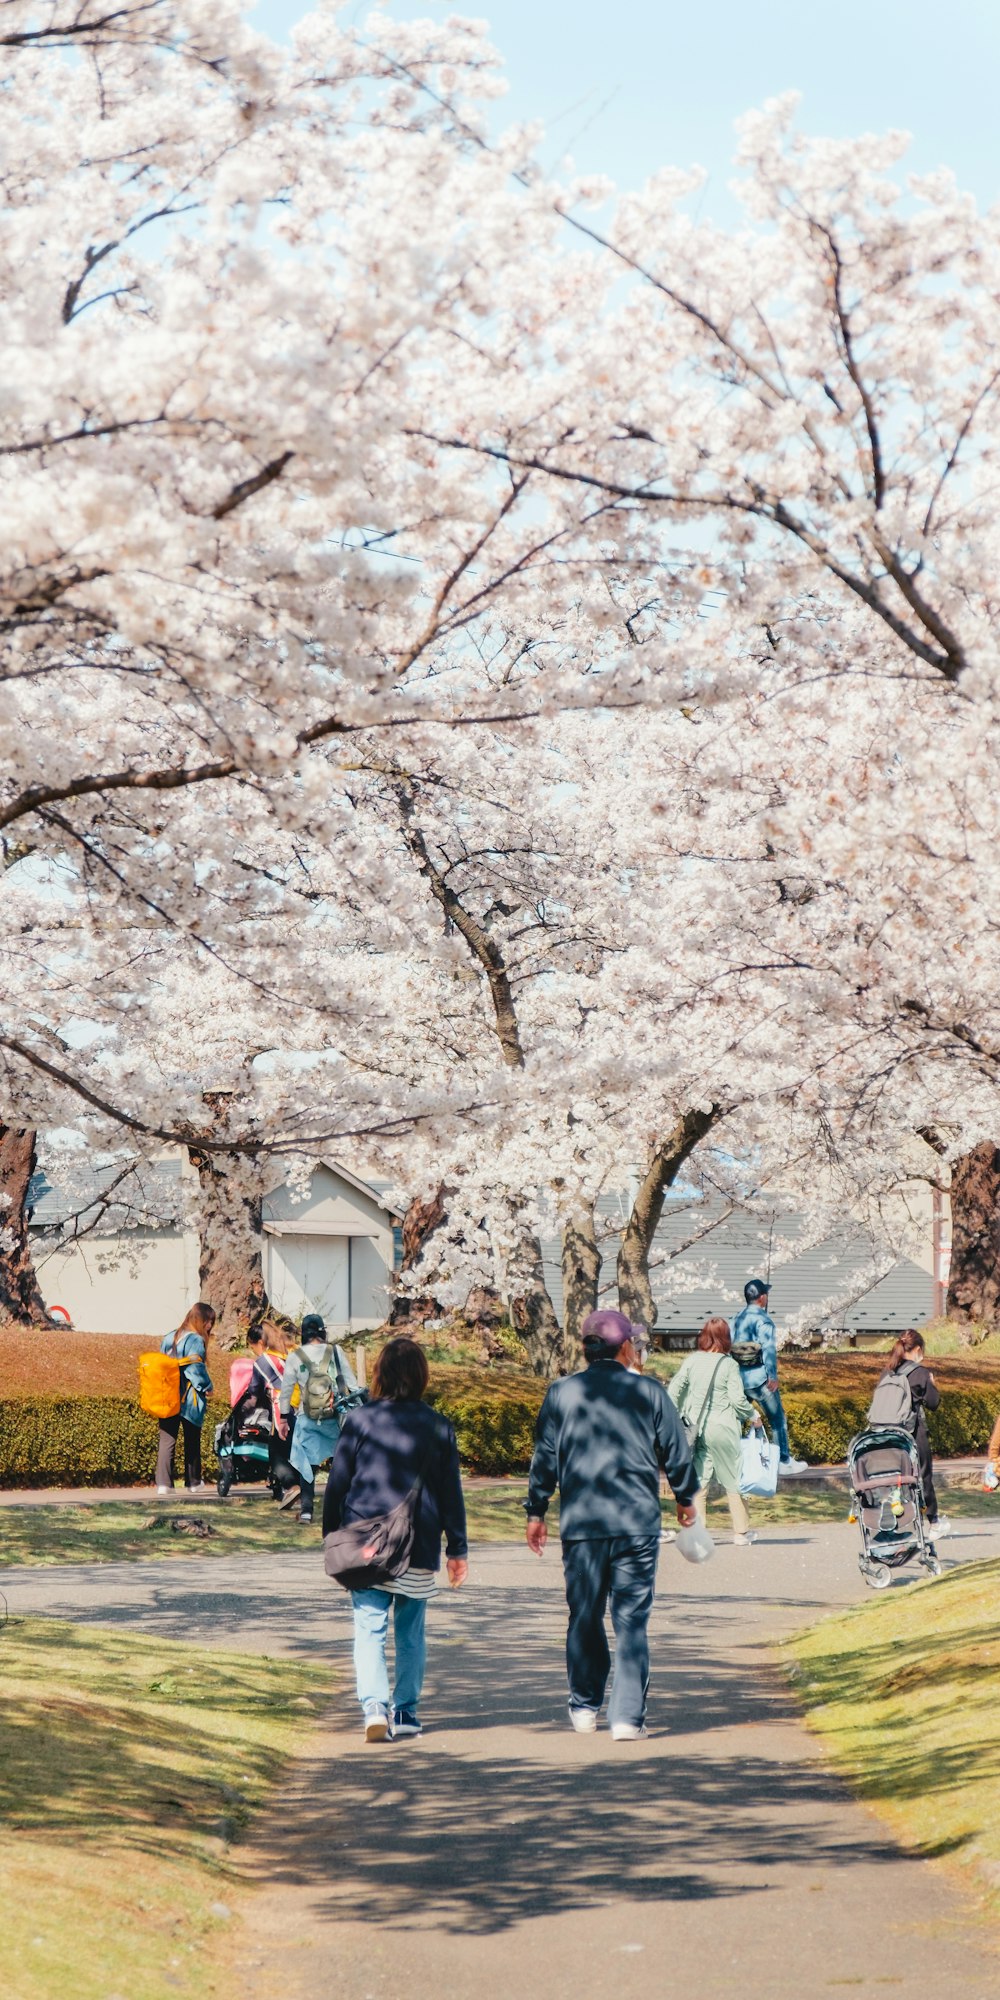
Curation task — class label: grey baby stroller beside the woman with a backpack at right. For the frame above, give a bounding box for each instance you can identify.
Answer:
[848,1428,942,1590]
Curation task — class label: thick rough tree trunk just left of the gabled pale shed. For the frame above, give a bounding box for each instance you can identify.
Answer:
[188,1146,268,1348]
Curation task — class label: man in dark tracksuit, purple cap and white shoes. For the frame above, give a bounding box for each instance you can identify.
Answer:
[526,1312,698,1742]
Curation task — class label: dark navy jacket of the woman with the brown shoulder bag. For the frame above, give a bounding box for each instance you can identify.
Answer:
[322,1396,468,1570]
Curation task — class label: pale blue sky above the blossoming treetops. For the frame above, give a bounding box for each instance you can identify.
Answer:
[254,0,1000,222]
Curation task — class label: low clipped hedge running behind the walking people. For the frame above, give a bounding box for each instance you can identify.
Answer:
[0,1370,996,1486]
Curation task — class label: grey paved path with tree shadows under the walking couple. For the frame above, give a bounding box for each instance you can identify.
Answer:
[0,1520,1000,2000]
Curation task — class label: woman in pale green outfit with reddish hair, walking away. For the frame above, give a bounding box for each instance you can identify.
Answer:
[668,1318,760,1548]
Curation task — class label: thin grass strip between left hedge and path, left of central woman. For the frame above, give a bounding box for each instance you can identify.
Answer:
[0,1494,322,1568]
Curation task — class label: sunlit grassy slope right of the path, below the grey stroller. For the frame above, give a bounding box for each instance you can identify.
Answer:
[790,1562,1000,1898]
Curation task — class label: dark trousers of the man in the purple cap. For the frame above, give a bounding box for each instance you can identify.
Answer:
[562,1534,660,1726]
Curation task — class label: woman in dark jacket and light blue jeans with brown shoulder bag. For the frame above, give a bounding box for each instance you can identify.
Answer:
[322,1338,468,1744]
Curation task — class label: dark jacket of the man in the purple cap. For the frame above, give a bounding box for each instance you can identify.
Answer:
[528,1360,698,1542]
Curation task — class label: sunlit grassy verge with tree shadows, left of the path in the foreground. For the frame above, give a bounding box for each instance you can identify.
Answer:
[0,1618,330,2000]
